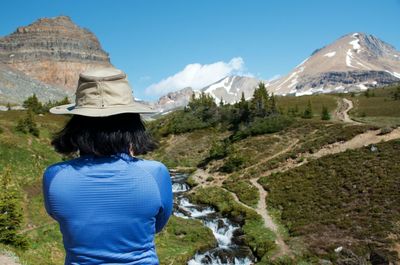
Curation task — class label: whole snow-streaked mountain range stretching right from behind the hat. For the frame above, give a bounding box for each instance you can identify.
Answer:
[156,33,400,112]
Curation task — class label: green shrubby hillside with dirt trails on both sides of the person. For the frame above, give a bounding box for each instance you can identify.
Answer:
[0,83,400,265]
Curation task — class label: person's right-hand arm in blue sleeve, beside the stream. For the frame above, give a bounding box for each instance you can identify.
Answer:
[155,163,173,233]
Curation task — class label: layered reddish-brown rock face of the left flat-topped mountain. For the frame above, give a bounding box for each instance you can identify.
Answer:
[0,16,111,92]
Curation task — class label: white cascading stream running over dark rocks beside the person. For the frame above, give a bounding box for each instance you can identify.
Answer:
[171,170,254,265]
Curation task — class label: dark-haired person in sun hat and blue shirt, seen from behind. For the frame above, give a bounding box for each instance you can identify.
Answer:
[43,68,173,265]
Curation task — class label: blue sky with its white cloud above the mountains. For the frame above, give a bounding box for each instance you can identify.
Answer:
[0,0,400,100]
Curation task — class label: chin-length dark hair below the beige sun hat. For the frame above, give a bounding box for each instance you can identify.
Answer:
[51,113,157,156]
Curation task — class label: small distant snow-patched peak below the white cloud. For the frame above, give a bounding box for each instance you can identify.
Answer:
[201,76,259,103]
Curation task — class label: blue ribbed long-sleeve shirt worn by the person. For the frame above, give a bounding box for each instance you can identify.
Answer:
[43,153,173,265]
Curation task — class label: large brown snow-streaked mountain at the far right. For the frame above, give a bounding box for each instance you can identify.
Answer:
[268,33,400,96]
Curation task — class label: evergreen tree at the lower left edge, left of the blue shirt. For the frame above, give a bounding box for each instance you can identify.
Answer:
[0,168,27,248]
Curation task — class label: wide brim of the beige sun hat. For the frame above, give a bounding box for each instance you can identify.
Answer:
[50,102,158,117]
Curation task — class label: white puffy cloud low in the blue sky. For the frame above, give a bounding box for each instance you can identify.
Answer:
[145,57,251,95]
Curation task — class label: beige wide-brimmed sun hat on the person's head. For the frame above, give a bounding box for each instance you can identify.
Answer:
[50,67,157,117]
